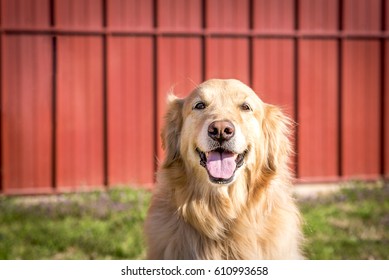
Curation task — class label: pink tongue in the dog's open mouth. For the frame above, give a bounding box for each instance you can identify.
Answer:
[207,152,236,179]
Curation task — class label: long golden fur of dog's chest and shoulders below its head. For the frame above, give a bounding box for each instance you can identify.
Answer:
[149,173,299,259]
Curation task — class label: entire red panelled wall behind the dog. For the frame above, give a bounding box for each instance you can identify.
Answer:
[0,0,389,194]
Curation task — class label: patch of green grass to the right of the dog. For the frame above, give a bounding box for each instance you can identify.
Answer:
[300,182,389,260]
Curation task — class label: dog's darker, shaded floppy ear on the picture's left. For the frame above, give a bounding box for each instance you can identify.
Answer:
[161,94,184,166]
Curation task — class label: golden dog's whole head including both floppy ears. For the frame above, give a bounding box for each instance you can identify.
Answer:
[162,79,289,185]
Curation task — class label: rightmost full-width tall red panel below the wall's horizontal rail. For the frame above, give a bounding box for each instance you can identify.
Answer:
[342,40,381,178]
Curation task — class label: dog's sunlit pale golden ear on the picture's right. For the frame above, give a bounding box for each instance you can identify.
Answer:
[262,104,292,174]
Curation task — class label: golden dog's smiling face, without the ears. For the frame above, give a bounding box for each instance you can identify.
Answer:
[180,80,263,184]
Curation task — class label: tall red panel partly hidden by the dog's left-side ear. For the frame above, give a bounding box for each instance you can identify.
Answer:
[157,37,202,158]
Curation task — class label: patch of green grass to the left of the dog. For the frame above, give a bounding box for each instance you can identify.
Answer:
[0,189,150,260]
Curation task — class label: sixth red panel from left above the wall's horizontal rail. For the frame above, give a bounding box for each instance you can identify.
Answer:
[253,0,295,32]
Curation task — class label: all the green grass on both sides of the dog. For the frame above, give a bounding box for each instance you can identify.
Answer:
[0,182,389,260]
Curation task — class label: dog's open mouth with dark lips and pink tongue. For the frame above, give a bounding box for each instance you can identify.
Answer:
[196,148,247,184]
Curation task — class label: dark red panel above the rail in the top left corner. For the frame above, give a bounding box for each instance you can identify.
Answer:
[1,0,50,29]
